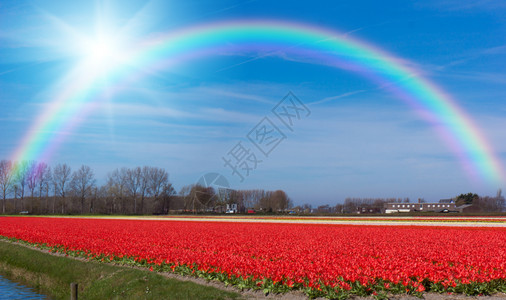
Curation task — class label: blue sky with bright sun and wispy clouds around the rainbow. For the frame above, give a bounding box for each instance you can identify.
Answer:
[0,0,506,205]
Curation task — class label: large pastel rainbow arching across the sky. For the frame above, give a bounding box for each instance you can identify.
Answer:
[8,20,506,184]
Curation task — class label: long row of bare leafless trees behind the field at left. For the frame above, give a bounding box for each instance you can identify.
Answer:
[0,160,292,215]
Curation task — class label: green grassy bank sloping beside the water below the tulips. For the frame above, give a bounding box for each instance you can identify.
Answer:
[0,241,239,299]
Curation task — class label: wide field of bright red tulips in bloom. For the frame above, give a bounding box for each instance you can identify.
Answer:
[0,217,506,298]
